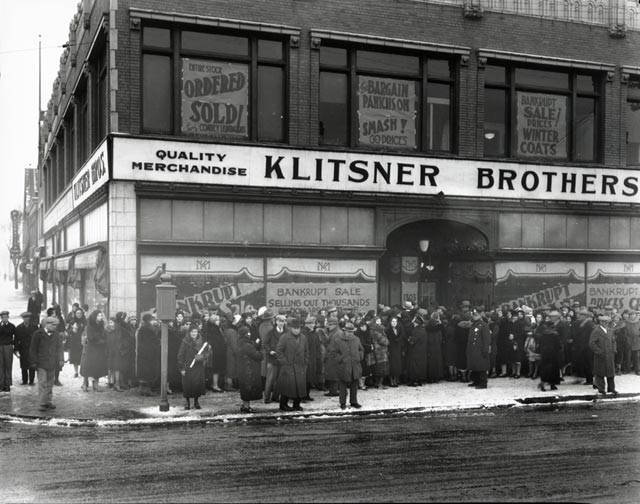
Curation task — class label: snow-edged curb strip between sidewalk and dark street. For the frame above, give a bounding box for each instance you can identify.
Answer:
[0,393,640,428]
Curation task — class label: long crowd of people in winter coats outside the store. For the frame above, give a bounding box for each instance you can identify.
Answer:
[0,293,640,413]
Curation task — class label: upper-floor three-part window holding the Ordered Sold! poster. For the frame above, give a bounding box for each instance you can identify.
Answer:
[142,27,286,142]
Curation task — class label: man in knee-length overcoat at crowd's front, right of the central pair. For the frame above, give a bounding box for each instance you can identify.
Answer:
[328,322,364,409]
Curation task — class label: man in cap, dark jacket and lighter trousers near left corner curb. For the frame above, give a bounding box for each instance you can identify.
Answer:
[29,317,64,411]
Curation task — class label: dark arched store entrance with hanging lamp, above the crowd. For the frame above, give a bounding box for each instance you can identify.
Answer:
[379,220,494,309]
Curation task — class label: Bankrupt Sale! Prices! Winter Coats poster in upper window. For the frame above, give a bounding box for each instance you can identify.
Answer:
[516,91,568,159]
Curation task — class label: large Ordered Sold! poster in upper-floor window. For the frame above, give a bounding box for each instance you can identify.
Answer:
[180,58,249,138]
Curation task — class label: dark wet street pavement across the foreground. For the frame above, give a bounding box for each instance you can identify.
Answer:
[0,403,640,503]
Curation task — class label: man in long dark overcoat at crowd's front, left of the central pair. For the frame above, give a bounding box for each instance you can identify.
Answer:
[276,318,308,411]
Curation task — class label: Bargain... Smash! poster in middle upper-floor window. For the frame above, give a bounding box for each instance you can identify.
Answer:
[358,75,418,149]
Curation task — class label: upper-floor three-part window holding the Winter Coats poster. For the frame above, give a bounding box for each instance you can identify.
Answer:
[484,65,601,162]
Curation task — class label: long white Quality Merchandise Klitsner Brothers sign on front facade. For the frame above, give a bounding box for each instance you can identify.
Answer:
[113,137,640,203]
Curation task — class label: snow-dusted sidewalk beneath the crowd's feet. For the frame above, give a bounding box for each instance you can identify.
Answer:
[0,359,640,426]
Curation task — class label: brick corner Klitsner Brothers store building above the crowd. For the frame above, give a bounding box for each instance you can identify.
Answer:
[40,0,640,313]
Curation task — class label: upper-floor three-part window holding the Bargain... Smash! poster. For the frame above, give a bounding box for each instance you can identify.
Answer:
[319,46,453,152]
